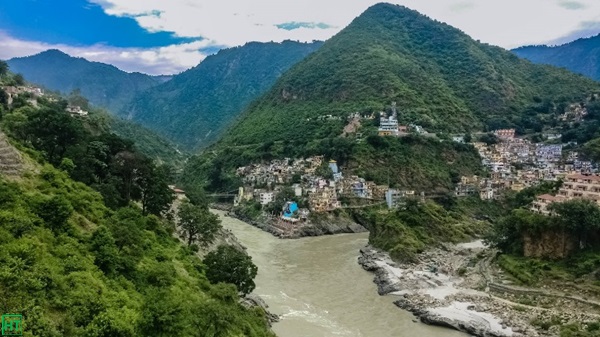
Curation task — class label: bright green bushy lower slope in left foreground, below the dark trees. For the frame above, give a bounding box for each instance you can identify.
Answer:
[0,169,272,336]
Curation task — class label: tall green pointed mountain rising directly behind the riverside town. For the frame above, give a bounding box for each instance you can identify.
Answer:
[183,4,600,194]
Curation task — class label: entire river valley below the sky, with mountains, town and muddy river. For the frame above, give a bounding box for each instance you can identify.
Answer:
[0,0,600,337]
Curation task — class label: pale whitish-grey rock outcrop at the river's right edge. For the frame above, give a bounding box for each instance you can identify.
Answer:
[358,247,519,337]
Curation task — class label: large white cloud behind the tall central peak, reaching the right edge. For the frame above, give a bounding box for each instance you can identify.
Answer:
[92,0,600,48]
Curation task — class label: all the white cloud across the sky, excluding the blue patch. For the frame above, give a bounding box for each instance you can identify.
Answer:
[0,0,600,74]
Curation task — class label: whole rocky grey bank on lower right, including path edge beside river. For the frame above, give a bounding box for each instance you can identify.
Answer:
[359,241,598,337]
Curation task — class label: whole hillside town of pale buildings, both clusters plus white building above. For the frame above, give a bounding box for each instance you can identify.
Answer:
[234,117,600,223]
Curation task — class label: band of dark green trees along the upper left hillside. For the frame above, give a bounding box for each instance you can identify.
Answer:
[2,96,173,215]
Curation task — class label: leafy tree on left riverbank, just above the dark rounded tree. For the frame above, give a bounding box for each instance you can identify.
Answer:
[179,202,221,247]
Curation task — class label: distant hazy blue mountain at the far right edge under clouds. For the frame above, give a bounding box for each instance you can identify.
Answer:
[513,34,600,81]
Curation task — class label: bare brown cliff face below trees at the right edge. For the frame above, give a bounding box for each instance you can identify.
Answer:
[523,231,577,259]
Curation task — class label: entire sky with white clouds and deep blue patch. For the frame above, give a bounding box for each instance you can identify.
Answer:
[0,0,600,74]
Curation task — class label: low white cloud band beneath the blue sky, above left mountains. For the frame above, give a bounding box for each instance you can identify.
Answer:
[0,31,210,75]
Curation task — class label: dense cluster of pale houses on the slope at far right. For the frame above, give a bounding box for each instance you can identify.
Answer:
[454,129,596,200]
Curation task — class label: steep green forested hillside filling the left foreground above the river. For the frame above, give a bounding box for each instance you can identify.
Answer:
[0,67,273,337]
